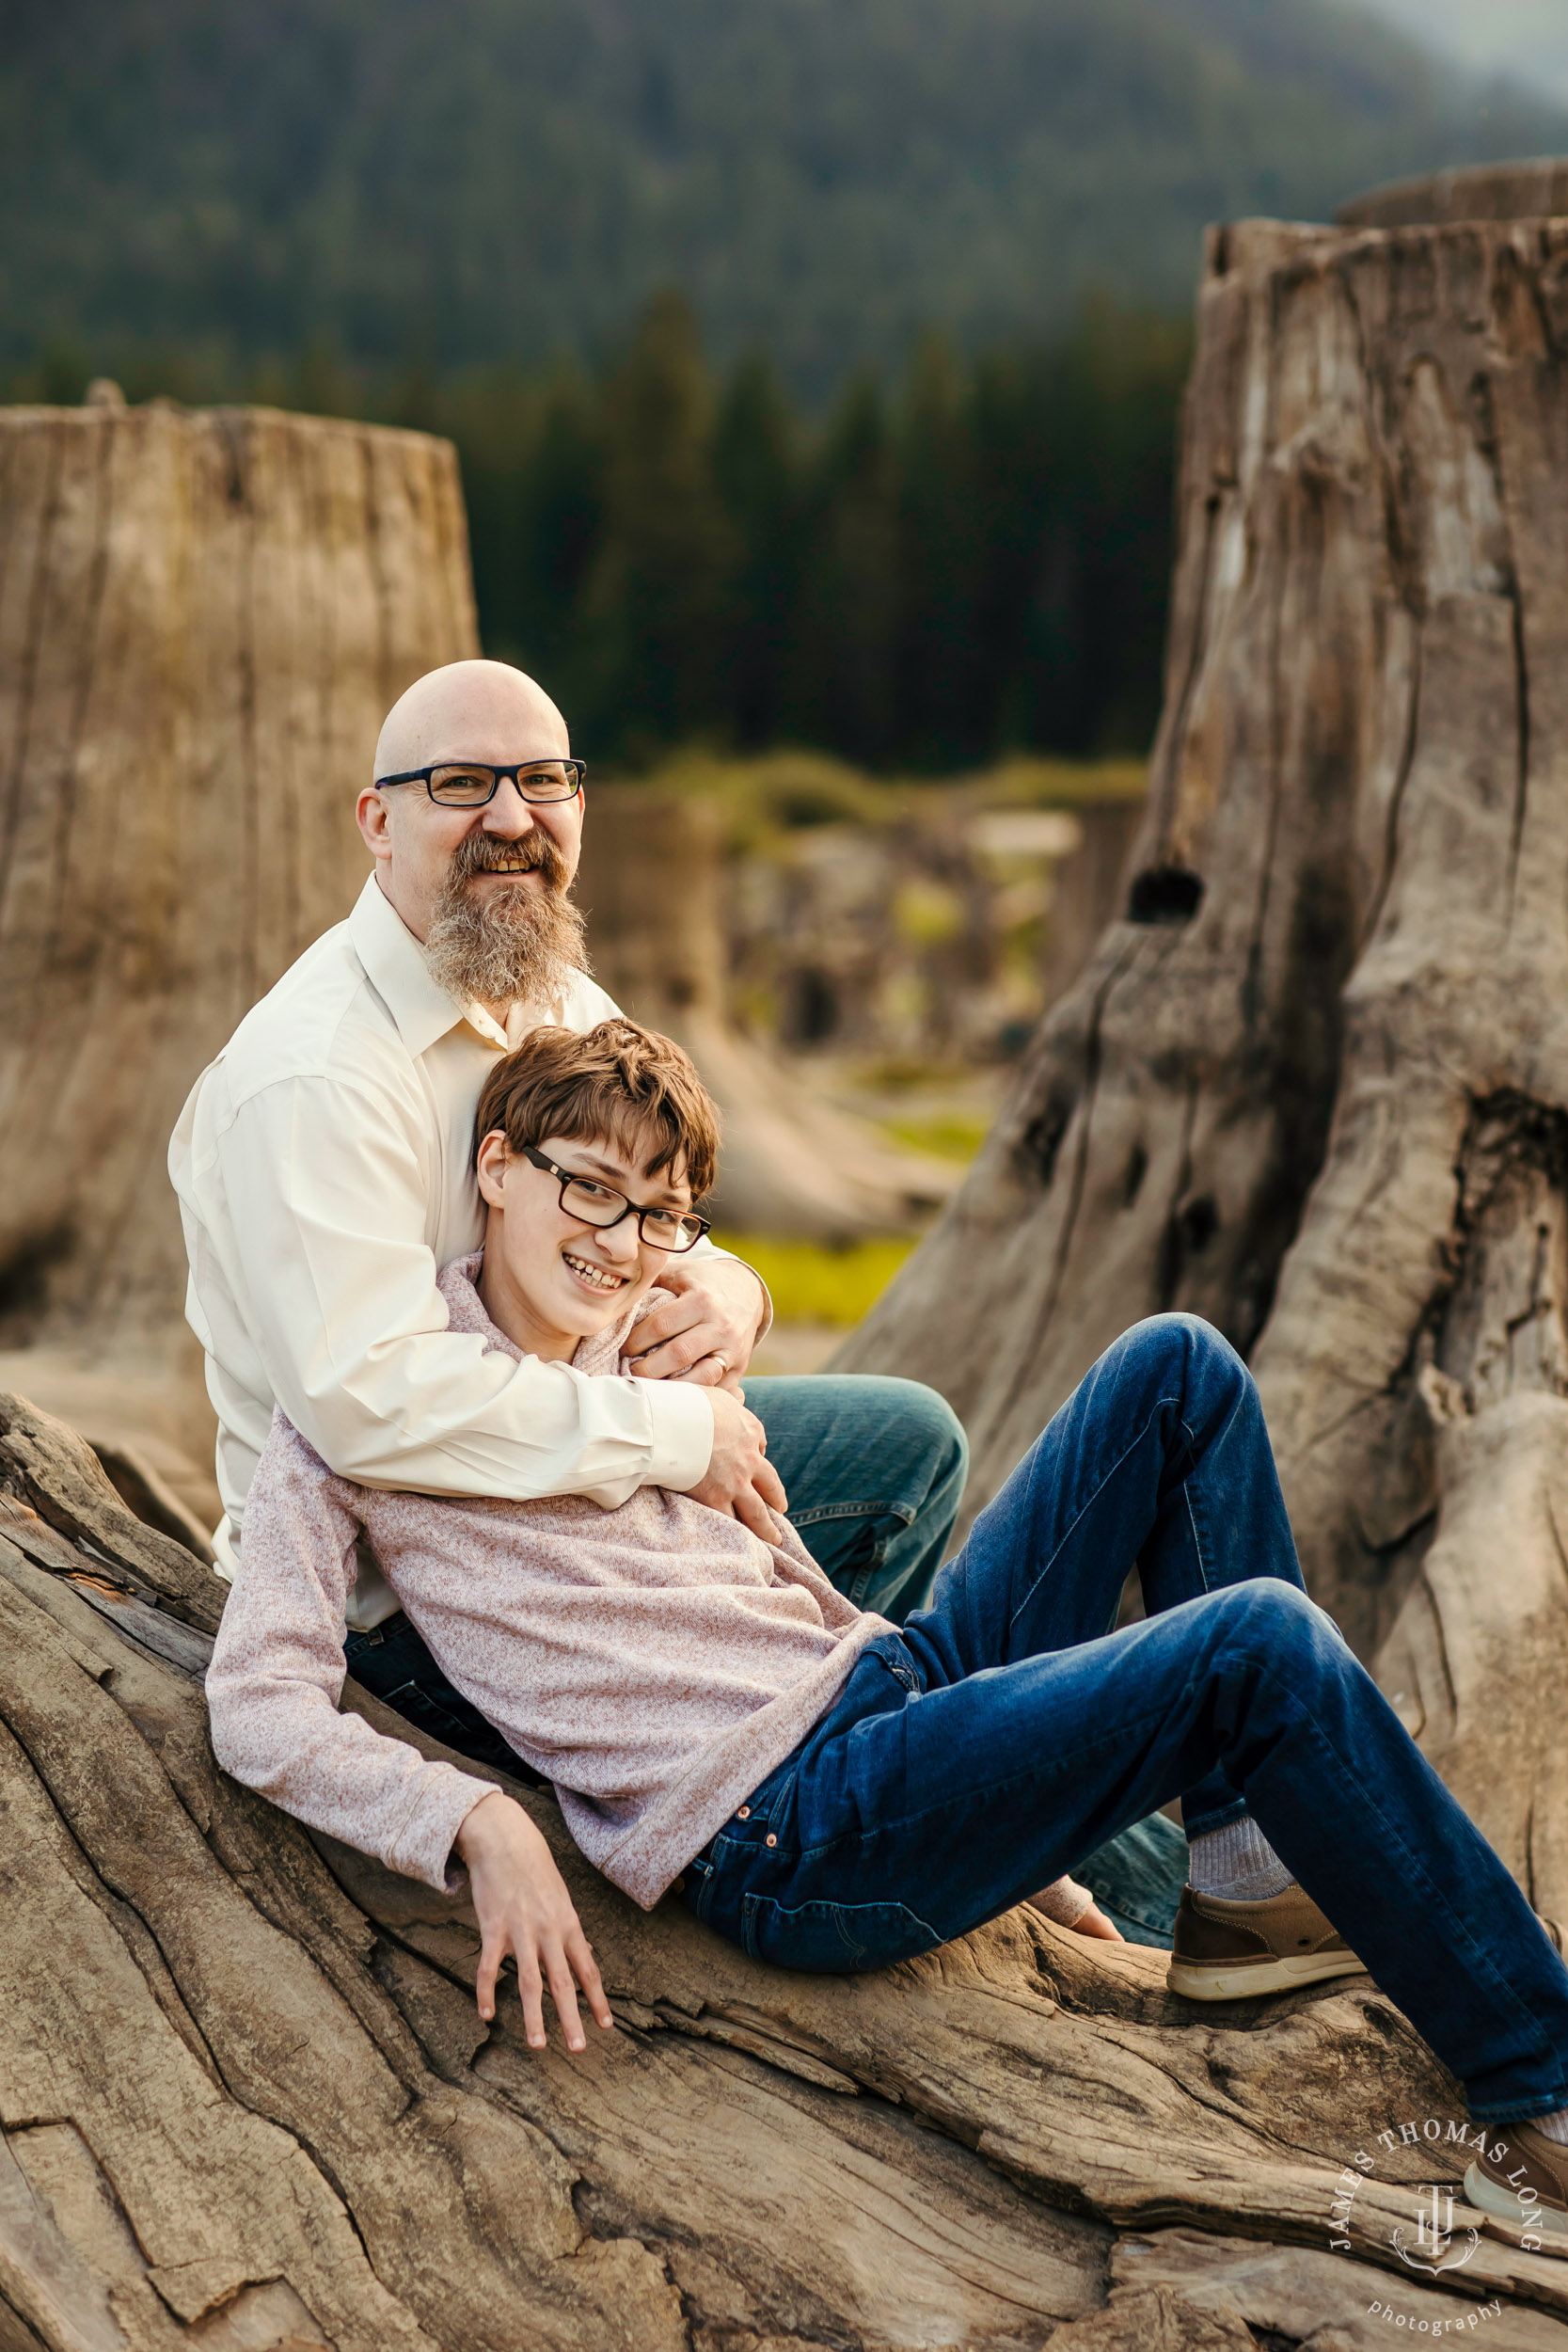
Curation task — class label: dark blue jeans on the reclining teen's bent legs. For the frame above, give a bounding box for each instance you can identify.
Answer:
[684,1315,1568,2122]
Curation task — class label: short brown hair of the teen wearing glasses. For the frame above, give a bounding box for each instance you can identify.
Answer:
[475,1021,720,1200]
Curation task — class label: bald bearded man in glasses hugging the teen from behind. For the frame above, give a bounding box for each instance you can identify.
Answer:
[169,661,982,1769]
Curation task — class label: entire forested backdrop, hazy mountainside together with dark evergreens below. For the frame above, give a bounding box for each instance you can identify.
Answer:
[12,0,1568,771]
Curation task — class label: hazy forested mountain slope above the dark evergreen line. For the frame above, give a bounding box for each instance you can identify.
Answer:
[0,0,1568,395]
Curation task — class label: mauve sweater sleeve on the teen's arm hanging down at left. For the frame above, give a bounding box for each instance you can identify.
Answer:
[207,1411,491,1894]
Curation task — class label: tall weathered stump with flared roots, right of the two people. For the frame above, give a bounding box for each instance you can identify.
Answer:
[842,183,1568,1917]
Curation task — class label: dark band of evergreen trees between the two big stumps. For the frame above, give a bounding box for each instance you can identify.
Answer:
[441,294,1190,771]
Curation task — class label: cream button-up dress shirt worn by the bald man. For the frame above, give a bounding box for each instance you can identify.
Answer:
[169,875,752,1628]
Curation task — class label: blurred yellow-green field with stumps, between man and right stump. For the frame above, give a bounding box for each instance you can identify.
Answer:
[580,753,1145,1374]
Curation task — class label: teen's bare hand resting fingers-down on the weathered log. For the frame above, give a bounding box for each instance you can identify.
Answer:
[456,1788,616,2051]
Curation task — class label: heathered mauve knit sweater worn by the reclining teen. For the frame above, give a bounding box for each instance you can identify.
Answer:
[207,1256,1088,1924]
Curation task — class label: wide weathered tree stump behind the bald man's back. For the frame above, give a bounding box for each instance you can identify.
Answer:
[0,400,477,1348]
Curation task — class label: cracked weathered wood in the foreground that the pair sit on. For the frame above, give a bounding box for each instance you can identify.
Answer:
[0,1397,1568,2352]
